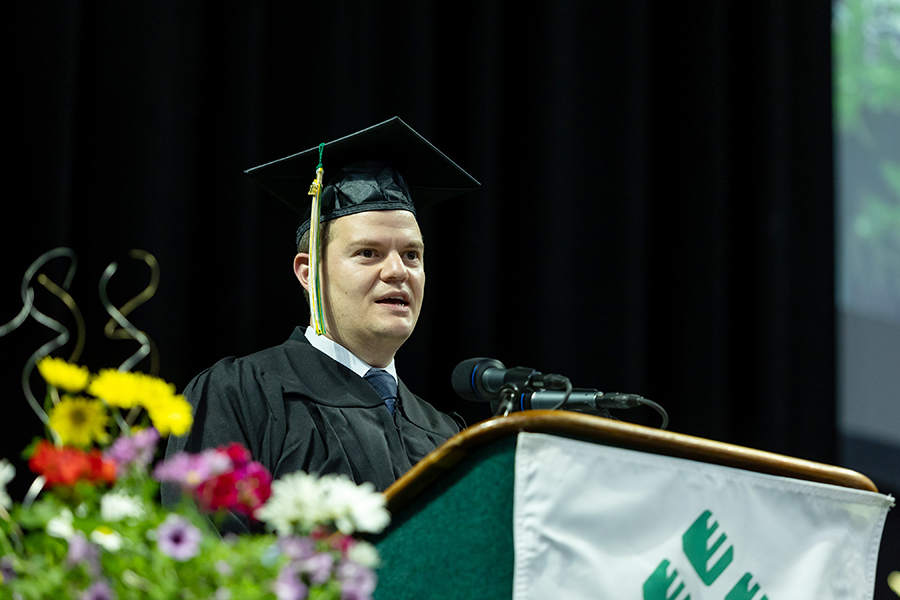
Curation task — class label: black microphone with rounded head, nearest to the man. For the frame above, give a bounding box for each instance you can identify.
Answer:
[450,358,568,402]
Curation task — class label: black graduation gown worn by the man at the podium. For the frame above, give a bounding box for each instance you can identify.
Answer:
[163,327,460,516]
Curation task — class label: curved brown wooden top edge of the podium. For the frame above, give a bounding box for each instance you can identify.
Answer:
[384,410,878,514]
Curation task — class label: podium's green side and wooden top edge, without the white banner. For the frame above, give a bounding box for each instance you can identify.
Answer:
[373,411,877,600]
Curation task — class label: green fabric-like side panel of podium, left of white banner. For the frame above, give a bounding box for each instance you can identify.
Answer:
[375,437,516,600]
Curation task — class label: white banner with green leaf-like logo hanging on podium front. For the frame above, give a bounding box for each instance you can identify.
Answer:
[513,433,893,600]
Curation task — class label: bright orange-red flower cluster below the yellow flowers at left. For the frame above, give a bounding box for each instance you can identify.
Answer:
[28,440,116,487]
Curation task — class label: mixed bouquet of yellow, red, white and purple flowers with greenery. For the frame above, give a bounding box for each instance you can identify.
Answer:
[0,358,389,600]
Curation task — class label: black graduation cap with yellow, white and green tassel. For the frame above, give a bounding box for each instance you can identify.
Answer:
[246,117,480,335]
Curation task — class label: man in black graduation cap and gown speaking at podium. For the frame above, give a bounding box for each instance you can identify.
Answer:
[163,117,479,530]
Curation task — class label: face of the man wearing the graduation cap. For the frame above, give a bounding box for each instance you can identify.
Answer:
[322,210,425,366]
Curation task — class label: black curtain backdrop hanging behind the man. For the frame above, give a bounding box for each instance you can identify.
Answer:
[0,0,836,488]
